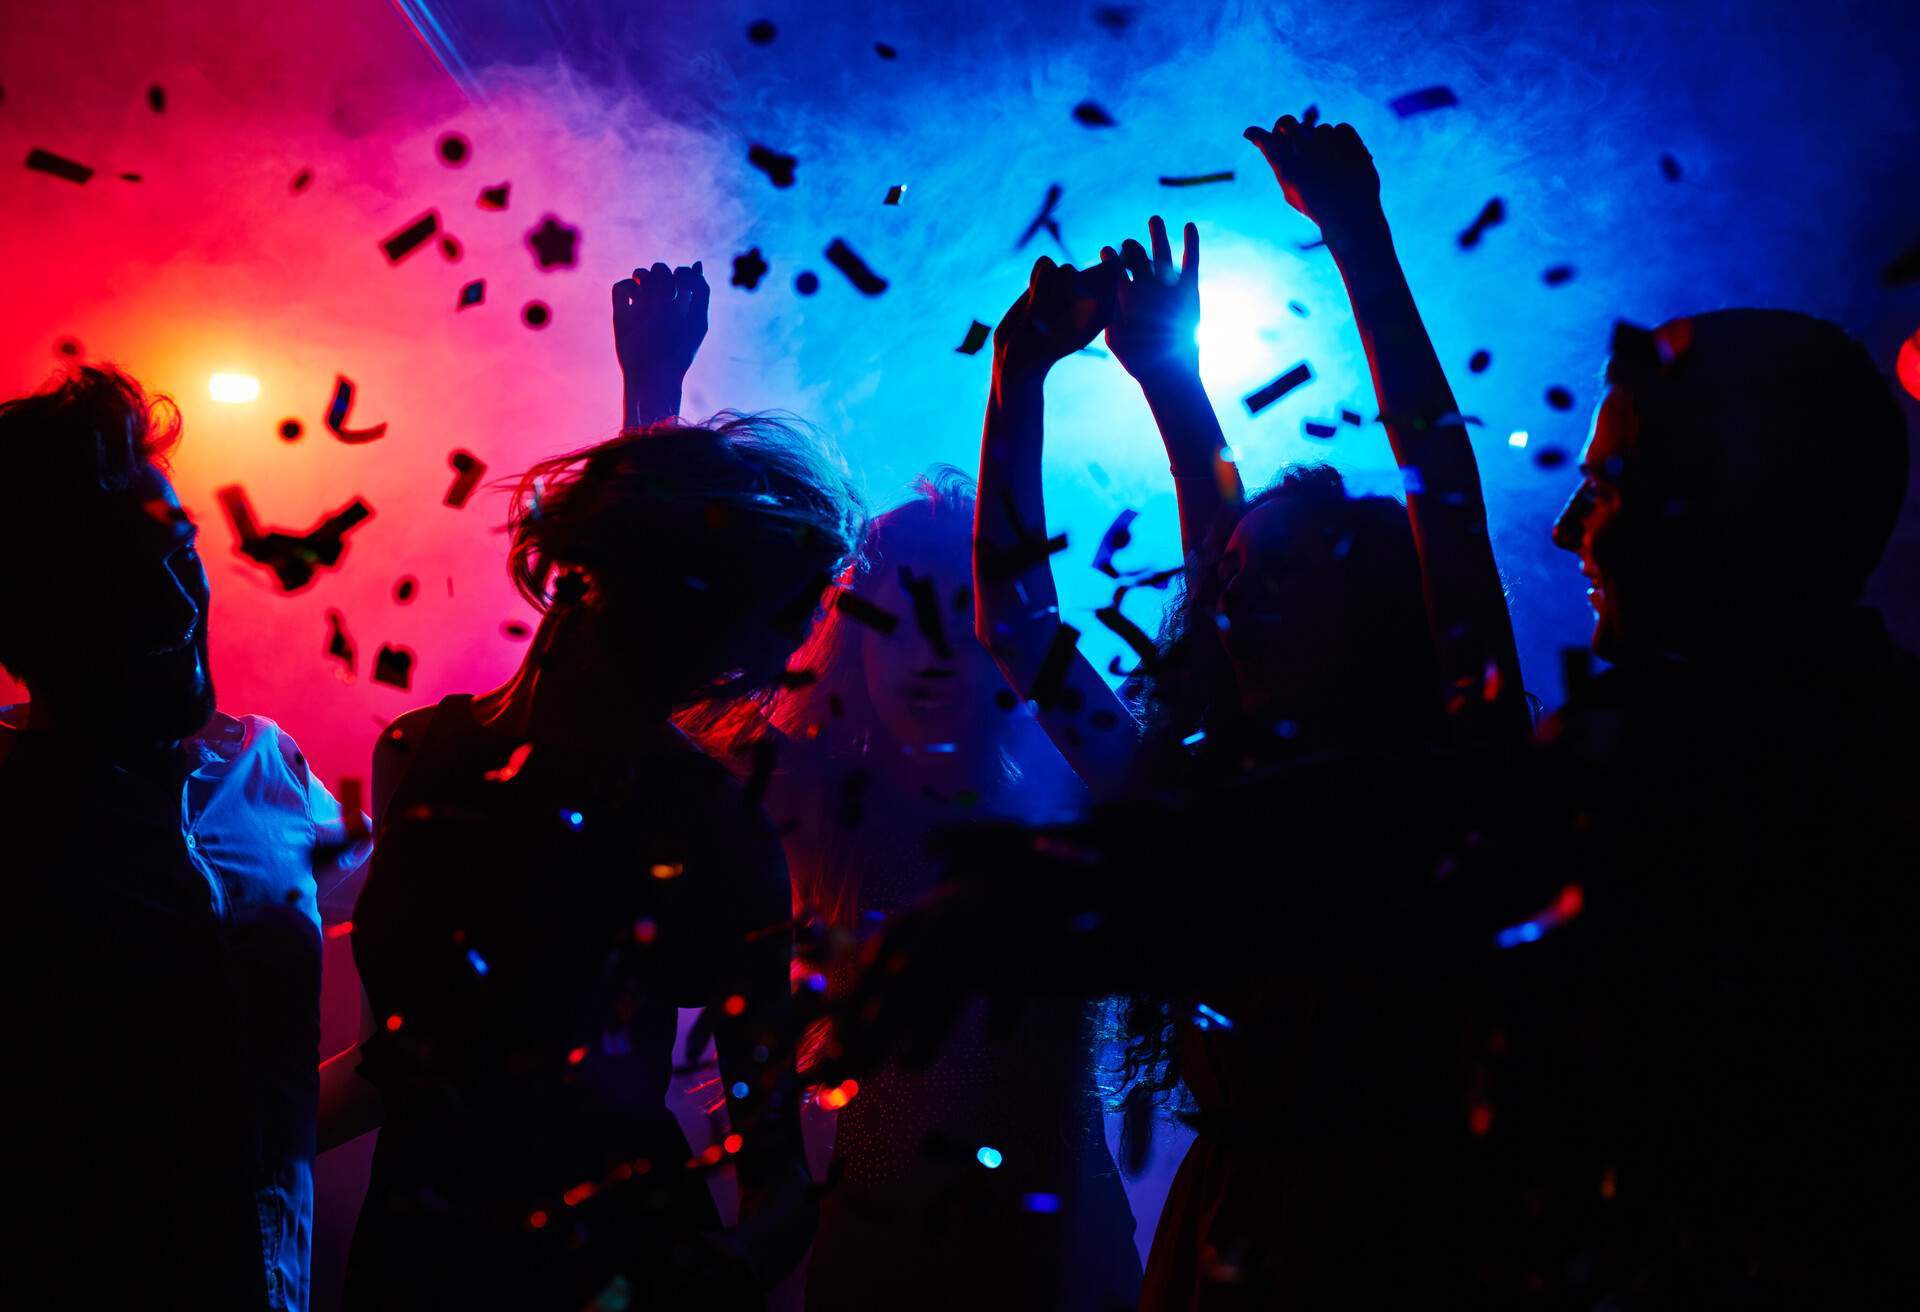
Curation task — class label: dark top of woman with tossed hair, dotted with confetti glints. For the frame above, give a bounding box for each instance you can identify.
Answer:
[348,697,797,1310]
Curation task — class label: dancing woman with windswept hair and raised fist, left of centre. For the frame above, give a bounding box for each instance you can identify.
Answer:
[337,267,860,1308]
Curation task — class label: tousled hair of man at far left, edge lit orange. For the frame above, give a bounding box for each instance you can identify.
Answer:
[0,365,180,684]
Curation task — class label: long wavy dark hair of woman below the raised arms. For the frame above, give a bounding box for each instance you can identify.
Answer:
[1112,465,1446,1114]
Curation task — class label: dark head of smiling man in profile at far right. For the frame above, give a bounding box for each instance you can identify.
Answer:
[1553,309,1907,661]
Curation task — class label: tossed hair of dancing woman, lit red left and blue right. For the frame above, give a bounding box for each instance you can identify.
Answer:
[507,411,866,705]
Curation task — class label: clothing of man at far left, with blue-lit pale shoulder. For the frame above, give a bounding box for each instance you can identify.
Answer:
[0,715,363,1312]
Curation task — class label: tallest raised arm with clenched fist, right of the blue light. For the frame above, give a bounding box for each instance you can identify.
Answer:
[1246,115,1530,745]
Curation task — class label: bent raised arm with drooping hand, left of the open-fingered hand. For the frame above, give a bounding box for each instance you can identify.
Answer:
[973,255,1139,797]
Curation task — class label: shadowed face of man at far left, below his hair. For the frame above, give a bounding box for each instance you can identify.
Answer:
[42,465,213,741]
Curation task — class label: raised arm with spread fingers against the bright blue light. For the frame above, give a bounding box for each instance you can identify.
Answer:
[1100,215,1242,561]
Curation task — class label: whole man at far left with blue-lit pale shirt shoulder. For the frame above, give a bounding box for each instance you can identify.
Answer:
[0,367,357,1310]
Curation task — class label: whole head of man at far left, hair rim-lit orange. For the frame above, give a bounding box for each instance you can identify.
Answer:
[0,365,213,747]
